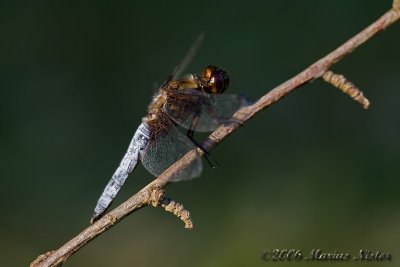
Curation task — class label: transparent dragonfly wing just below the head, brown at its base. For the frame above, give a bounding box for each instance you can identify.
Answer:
[163,89,250,132]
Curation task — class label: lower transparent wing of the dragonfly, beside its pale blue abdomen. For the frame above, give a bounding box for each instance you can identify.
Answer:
[141,121,203,182]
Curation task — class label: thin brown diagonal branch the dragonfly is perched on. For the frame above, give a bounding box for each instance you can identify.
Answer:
[31,4,400,267]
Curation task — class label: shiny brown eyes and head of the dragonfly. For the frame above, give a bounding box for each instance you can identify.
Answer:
[203,66,229,94]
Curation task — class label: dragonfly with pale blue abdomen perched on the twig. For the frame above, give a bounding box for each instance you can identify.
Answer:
[91,37,250,223]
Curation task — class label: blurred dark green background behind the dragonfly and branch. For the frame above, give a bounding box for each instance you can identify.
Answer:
[0,0,400,267]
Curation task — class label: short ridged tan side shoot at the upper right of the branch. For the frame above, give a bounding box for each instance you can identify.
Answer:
[322,70,369,109]
